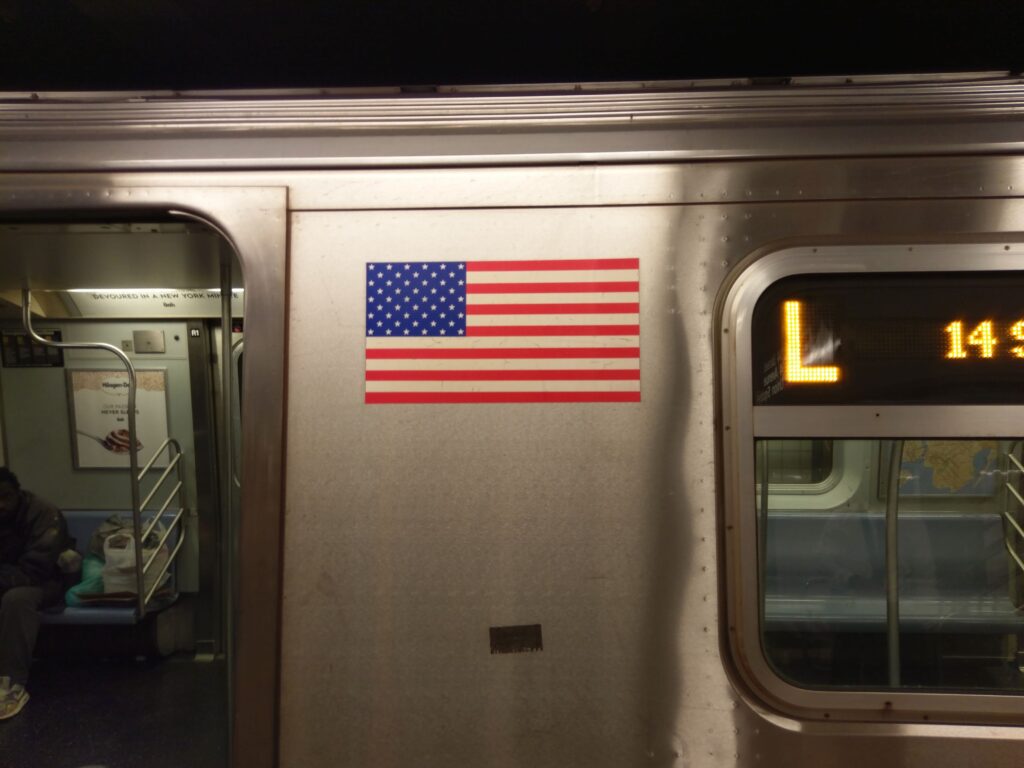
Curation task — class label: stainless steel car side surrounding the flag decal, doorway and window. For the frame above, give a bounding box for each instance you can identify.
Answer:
[6,74,1024,768]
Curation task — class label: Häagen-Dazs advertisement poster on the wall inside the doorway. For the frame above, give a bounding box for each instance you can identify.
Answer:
[68,370,167,469]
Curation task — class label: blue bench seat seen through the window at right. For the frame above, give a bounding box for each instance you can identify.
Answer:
[764,512,1024,634]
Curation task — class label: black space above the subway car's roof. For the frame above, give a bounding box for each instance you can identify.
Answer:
[0,0,1024,91]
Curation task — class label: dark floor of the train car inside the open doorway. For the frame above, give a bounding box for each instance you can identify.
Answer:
[0,656,227,768]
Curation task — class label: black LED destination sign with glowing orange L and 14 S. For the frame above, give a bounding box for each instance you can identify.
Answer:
[752,272,1024,406]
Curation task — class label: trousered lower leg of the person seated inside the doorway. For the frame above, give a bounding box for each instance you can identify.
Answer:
[0,587,46,720]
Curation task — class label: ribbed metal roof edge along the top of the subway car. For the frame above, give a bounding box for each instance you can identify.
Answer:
[0,73,1024,132]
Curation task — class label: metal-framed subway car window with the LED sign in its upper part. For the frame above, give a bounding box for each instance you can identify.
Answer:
[723,245,1024,718]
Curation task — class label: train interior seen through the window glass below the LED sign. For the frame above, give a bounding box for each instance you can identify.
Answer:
[756,439,1024,692]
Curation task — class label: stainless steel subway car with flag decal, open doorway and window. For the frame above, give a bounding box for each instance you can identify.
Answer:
[0,73,1024,768]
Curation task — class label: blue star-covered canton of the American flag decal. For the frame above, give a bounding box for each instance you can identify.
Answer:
[367,261,466,338]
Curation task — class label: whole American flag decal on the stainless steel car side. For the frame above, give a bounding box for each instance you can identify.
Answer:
[366,258,640,403]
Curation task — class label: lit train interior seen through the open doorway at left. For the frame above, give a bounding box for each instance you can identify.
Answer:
[0,217,244,768]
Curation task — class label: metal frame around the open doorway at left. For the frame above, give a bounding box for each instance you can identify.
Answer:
[0,179,288,768]
